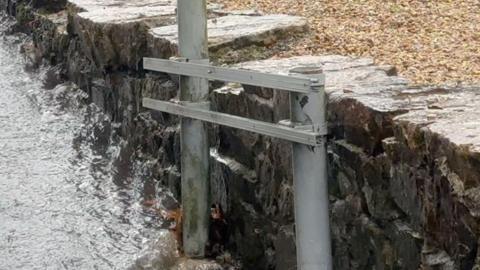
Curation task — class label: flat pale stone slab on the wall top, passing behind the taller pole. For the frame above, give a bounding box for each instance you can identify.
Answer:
[150,14,307,49]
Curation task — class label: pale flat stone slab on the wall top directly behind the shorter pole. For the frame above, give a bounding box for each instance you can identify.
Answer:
[235,55,408,111]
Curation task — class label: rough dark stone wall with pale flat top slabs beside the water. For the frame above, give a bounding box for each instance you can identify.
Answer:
[0,0,480,269]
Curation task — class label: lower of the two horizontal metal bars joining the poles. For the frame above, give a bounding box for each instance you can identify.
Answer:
[143,98,322,146]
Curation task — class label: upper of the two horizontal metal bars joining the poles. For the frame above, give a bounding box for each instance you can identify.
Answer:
[143,58,325,93]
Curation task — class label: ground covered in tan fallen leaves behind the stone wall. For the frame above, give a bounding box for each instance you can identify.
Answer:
[211,0,480,84]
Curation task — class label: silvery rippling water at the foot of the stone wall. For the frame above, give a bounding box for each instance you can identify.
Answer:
[0,15,185,269]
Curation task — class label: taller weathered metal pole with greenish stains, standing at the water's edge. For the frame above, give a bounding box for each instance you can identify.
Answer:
[177,0,209,258]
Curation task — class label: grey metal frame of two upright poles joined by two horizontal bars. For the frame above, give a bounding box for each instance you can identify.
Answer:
[143,0,332,270]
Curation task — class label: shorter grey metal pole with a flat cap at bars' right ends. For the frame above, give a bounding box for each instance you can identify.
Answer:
[290,68,332,270]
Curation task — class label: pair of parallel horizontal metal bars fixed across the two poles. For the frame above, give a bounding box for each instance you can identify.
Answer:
[143,58,327,146]
